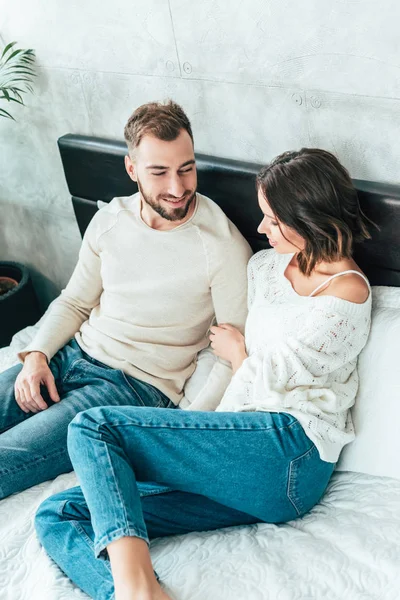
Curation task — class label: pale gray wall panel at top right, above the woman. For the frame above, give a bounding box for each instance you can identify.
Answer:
[170,0,400,97]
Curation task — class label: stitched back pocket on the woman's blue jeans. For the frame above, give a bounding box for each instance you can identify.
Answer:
[287,444,335,517]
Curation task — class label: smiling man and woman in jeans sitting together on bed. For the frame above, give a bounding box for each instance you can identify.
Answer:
[0,102,371,600]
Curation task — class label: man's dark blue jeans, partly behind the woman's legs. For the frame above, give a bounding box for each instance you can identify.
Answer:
[0,340,175,499]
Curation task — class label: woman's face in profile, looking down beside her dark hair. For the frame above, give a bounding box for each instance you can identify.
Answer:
[257,189,305,254]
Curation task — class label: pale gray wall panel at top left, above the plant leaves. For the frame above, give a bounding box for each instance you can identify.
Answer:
[0,0,179,76]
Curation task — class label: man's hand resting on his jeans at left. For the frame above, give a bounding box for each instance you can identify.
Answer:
[14,352,60,413]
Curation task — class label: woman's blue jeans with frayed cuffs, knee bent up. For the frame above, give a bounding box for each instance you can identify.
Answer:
[35,407,334,600]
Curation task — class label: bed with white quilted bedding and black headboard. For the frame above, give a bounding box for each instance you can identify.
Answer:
[0,135,400,600]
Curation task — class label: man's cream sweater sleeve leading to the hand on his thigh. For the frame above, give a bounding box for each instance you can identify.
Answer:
[18,212,103,361]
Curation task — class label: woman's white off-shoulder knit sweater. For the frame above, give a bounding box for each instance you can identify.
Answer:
[217,250,371,462]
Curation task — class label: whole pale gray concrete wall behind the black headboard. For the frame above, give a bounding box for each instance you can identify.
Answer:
[0,0,400,306]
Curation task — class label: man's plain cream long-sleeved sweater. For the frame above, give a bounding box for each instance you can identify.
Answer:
[19,194,251,403]
